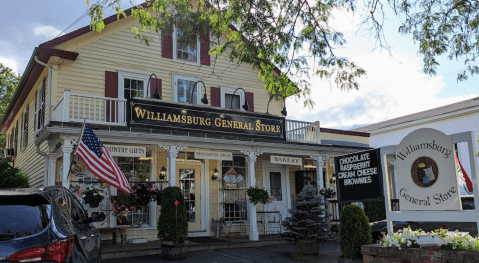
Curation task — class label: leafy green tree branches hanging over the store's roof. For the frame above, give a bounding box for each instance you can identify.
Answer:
[87,0,365,105]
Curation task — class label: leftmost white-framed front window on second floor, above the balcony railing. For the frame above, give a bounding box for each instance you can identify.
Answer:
[118,71,149,99]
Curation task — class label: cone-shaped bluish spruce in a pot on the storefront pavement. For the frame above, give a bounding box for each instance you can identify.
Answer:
[281,185,332,254]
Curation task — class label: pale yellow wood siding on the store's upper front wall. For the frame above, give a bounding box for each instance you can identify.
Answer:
[52,18,282,115]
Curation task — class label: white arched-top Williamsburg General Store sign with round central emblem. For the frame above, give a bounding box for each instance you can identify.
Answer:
[395,128,461,211]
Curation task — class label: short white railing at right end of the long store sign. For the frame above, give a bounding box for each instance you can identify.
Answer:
[285,120,321,144]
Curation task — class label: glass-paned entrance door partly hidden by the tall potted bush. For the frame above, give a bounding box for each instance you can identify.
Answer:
[176,164,201,232]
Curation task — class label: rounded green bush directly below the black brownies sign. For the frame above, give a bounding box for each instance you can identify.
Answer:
[339,204,372,259]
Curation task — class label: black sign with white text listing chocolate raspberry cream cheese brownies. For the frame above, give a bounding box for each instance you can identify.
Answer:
[334,149,384,202]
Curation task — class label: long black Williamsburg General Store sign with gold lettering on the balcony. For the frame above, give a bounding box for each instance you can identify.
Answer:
[127,99,285,140]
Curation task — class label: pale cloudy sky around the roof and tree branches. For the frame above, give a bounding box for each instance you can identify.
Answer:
[0,0,479,130]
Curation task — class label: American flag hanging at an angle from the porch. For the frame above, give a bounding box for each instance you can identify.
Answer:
[75,124,131,194]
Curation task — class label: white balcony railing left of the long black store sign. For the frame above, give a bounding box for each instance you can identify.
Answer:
[52,90,126,126]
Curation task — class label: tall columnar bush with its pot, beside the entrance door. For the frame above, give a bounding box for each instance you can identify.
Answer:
[158,186,188,259]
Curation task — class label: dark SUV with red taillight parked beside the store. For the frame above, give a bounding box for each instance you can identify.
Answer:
[0,186,105,263]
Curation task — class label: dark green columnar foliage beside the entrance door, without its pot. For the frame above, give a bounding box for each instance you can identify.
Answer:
[158,186,188,244]
